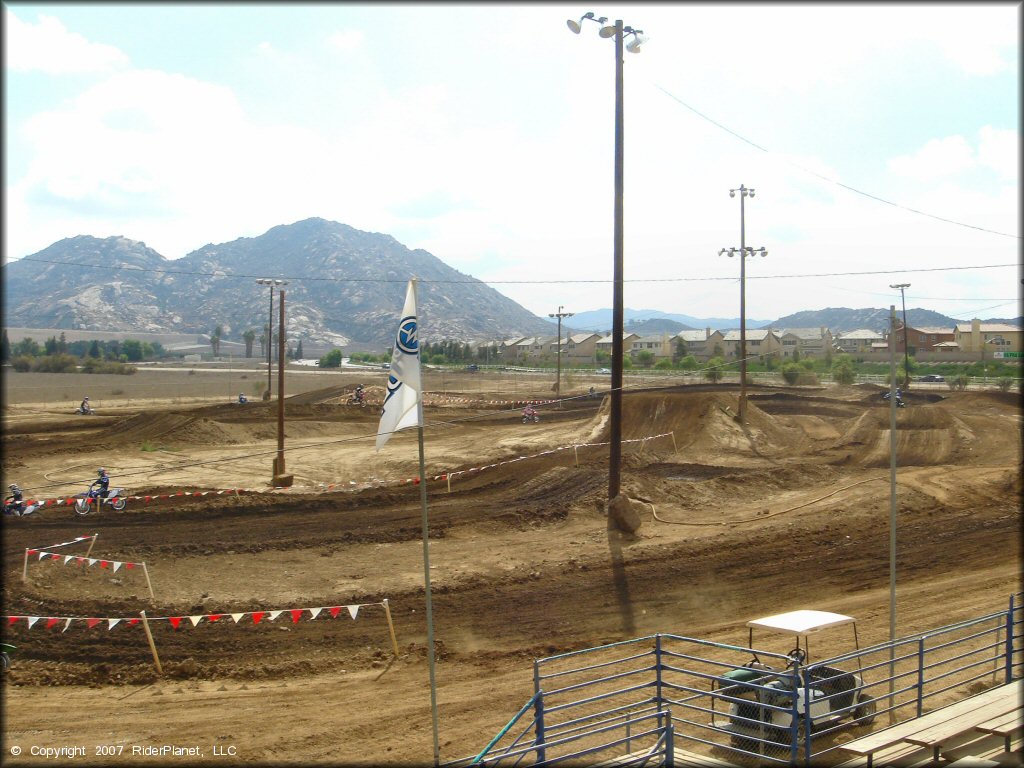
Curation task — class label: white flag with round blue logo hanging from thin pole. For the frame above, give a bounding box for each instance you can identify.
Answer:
[377,280,423,451]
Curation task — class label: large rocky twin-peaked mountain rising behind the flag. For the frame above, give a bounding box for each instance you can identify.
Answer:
[2,218,555,348]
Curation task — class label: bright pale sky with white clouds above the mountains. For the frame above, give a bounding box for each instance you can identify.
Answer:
[3,2,1021,322]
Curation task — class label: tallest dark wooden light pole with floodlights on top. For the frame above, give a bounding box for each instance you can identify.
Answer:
[566,12,646,501]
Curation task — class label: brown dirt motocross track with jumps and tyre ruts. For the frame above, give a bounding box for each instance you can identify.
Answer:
[3,385,1022,765]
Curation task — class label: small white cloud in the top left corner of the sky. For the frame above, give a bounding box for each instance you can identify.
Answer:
[4,8,128,75]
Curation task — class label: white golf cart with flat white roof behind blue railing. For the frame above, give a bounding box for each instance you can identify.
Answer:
[712,610,877,754]
